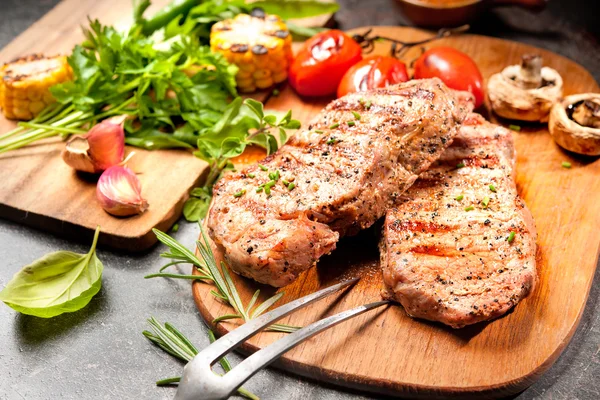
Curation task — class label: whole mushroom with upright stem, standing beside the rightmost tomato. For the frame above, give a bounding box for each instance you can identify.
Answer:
[488,54,563,122]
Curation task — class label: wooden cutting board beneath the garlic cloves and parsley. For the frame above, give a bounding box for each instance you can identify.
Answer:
[0,0,331,251]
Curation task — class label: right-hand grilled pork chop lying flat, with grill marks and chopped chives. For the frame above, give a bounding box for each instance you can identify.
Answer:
[380,114,537,328]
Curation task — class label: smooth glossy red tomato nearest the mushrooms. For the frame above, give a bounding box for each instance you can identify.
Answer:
[415,47,485,107]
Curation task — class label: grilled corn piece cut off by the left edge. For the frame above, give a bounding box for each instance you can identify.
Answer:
[0,54,71,120]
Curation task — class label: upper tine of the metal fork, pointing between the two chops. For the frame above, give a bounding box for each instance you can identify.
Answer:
[197,278,358,365]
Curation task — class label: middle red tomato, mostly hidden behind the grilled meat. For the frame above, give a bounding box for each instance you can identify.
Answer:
[338,56,408,97]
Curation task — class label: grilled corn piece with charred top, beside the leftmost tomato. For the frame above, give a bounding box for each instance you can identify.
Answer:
[210,9,292,93]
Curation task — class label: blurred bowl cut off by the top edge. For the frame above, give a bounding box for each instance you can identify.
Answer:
[397,0,548,28]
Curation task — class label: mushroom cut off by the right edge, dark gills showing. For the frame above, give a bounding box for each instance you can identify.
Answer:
[548,93,600,156]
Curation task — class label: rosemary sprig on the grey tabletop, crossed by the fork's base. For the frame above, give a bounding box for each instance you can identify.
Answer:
[142,317,259,400]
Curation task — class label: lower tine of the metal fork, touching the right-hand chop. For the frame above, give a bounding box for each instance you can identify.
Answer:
[224,301,389,394]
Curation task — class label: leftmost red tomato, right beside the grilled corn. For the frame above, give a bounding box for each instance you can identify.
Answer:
[289,29,362,96]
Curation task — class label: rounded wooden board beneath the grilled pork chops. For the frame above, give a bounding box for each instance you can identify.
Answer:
[193,27,600,398]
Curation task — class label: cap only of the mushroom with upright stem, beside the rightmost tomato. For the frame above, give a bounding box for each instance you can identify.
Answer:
[488,65,563,122]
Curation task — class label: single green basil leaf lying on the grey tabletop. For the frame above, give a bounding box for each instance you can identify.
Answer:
[0,227,104,318]
